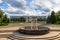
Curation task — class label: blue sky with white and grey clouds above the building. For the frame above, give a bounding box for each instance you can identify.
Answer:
[0,0,60,16]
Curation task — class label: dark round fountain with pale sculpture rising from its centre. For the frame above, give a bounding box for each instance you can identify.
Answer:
[18,17,49,35]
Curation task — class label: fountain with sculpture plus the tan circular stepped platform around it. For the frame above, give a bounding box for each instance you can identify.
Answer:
[7,18,60,40]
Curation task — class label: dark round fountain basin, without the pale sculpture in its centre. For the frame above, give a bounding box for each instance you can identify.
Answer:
[18,26,50,35]
